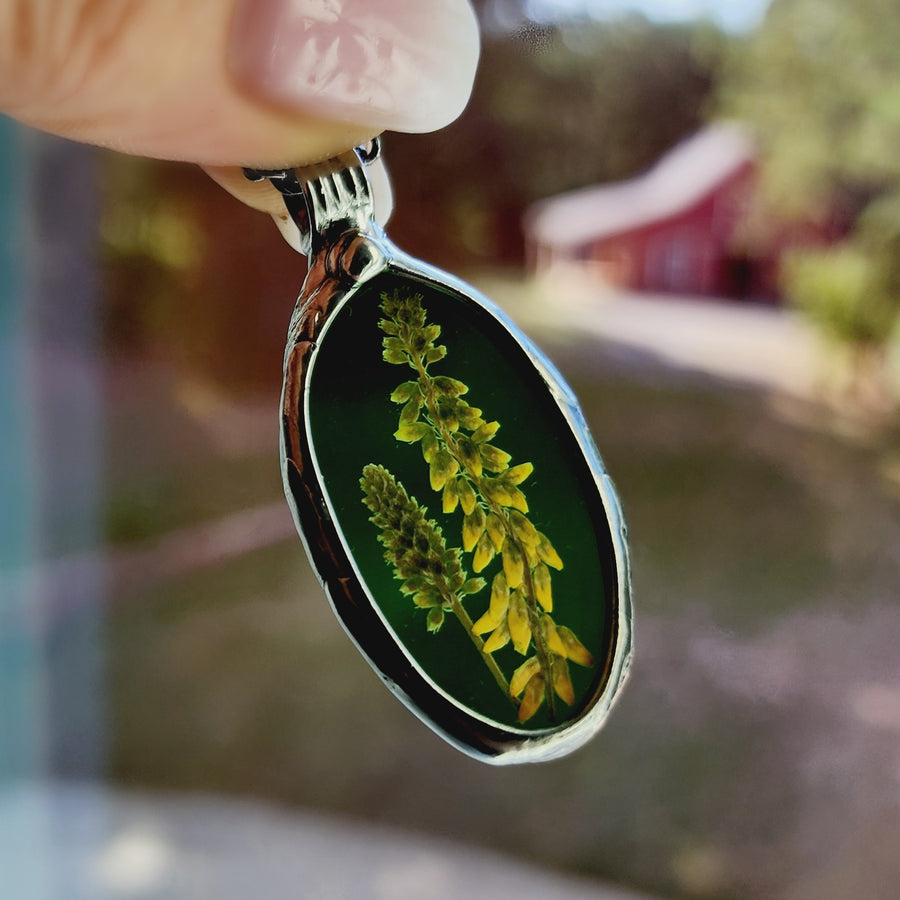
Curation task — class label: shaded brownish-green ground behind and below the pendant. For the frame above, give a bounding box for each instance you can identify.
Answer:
[98,286,900,900]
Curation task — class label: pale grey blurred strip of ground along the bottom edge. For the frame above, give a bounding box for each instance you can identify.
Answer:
[0,783,647,900]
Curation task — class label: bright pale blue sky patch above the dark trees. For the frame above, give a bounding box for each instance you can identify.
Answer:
[528,0,769,31]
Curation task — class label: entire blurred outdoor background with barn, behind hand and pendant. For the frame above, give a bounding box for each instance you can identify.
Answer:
[0,0,900,900]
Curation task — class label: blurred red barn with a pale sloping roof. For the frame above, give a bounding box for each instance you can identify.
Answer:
[525,123,781,299]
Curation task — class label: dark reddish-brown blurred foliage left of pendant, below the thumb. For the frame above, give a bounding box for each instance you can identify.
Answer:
[98,154,297,396]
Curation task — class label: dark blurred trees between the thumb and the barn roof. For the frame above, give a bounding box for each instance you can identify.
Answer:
[387,17,725,266]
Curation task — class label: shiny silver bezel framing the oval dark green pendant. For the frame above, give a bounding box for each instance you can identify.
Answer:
[281,222,632,765]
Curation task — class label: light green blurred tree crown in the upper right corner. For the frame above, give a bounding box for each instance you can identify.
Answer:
[719,0,900,219]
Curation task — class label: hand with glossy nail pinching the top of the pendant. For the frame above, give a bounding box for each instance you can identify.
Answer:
[0,0,478,211]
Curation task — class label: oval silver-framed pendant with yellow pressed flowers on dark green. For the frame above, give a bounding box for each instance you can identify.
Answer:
[246,143,632,764]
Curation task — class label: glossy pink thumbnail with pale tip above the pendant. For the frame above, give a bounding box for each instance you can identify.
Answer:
[228,0,478,132]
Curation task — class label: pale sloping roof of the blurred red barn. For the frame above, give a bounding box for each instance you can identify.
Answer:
[525,122,755,246]
